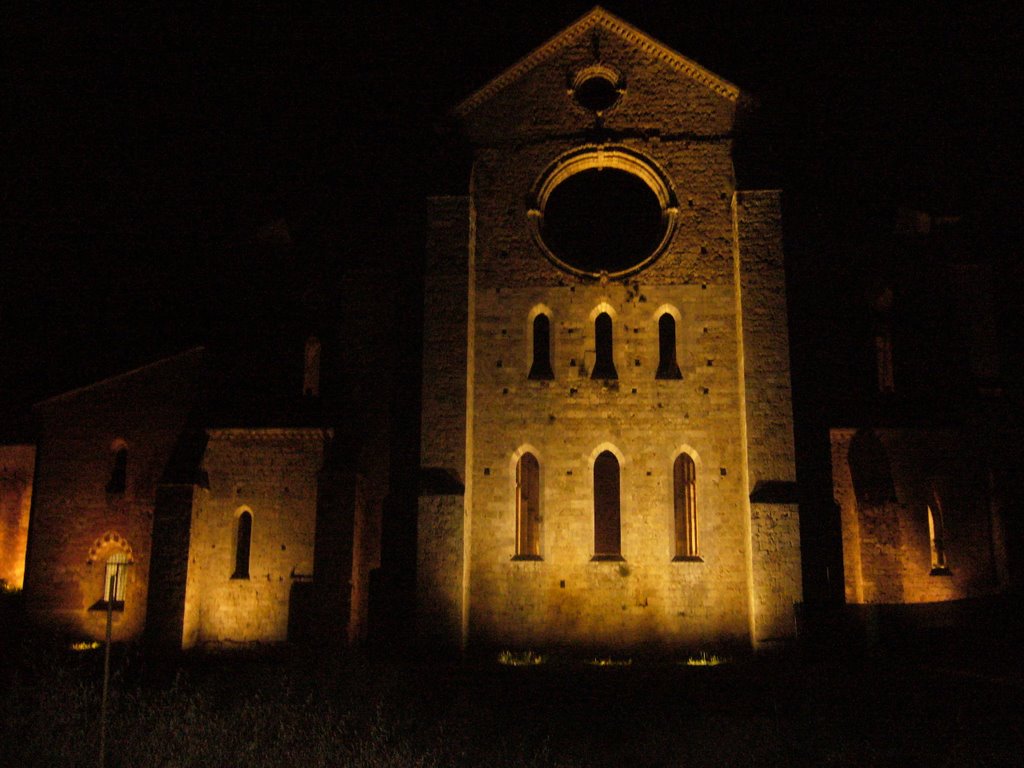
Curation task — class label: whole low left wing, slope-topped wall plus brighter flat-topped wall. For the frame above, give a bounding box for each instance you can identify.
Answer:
[19,335,370,651]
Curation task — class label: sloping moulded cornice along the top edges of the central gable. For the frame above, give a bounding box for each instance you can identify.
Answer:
[455,5,739,117]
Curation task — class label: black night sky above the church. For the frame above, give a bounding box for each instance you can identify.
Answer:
[0,0,1024,406]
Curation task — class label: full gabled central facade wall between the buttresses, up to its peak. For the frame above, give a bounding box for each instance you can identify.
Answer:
[456,20,799,648]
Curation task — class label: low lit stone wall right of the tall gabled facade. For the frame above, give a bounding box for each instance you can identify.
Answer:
[830,429,1002,603]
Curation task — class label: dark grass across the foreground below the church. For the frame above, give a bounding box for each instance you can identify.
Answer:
[0,648,1024,768]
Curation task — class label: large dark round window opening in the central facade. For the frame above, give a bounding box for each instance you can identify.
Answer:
[540,167,668,274]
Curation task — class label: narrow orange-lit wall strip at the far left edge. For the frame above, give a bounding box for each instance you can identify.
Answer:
[0,445,36,589]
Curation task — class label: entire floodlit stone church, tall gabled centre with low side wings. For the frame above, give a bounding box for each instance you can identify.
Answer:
[0,8,1022,653]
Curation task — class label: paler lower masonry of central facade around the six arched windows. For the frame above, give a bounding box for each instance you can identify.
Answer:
[470,284,748,647]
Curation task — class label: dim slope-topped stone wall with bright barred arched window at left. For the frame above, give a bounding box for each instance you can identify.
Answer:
[25,350,204,640]
